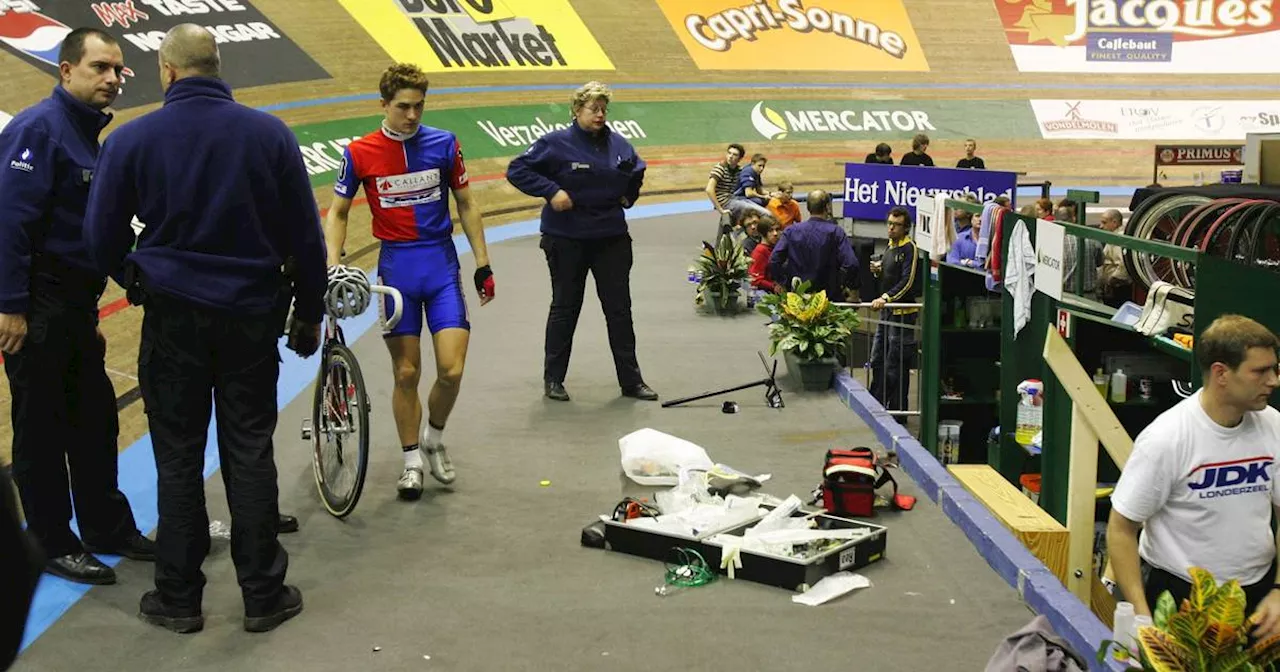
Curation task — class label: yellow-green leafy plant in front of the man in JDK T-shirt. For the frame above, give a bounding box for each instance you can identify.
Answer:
[1098,567,1280,672]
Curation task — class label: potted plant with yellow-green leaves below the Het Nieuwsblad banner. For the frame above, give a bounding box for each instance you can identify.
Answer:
[756,282,858,390]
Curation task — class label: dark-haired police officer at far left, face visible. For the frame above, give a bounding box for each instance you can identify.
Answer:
[0,28,155,584]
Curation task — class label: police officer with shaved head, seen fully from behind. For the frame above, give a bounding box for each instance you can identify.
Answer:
[84,24,325,632]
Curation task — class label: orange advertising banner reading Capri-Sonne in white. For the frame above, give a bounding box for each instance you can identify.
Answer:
[655,0,929,72]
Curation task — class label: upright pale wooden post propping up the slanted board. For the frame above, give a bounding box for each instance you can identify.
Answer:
[1070,404,1098,604]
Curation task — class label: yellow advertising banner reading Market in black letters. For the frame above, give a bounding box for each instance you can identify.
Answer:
[338,0,613,72]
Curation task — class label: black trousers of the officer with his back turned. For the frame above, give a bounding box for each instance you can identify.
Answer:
[138,294,289,616]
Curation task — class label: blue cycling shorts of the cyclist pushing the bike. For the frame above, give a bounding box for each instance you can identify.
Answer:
[378,239,471,338]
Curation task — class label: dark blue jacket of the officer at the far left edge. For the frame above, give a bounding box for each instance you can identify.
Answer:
[0,86,111,314]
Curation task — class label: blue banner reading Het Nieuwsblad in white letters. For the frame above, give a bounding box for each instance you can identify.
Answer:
[844,164,1018,220]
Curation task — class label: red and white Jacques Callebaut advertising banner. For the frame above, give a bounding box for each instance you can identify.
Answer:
[993,0,1280,73]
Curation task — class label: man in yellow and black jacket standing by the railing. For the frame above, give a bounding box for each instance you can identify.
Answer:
[870,207,920,411]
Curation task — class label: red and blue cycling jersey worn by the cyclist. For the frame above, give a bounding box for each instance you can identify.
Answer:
[334,125,468,243]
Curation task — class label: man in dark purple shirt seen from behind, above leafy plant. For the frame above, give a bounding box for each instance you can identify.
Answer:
[769,189,858,301]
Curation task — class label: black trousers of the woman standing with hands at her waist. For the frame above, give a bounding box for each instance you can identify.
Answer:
[540,233,644,388]
